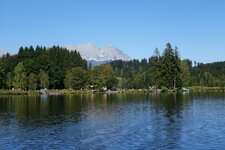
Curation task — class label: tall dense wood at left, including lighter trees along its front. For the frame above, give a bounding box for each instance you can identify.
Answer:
[0,46,87,90]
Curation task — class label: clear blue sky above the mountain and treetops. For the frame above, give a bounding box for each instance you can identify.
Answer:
[0,0,225,63]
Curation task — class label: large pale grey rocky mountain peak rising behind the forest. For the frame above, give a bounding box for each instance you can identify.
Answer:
[65,43,131,61]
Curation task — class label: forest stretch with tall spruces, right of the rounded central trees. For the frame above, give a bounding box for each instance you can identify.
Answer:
[111,43,225,89]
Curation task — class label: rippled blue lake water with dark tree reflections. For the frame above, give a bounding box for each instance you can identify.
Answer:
[0,93,225,149]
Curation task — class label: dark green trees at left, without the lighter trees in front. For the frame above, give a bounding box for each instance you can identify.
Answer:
[0,46,87,89]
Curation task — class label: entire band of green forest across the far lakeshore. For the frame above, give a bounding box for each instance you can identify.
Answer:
[0,43,225,90]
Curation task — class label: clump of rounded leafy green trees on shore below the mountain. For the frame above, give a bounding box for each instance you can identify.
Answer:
[64,64,118,90]
